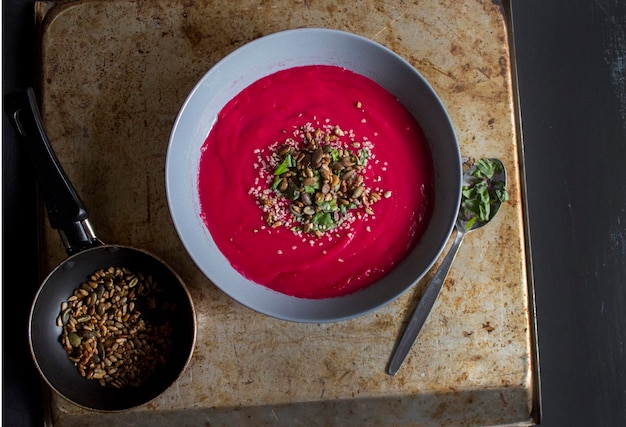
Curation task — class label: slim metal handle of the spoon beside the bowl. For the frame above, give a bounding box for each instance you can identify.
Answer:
[387,227,466,375]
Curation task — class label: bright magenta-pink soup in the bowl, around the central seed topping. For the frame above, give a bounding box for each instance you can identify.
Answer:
[197,65,434,299]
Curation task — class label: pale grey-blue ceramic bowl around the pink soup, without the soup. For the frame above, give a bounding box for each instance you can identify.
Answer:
[165,28,462,323]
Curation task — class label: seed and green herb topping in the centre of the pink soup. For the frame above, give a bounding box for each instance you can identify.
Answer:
[250,112,391,237]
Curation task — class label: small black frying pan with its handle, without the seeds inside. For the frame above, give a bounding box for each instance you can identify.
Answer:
[5,88,196,411]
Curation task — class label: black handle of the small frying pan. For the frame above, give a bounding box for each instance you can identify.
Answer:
[4,88,102,255]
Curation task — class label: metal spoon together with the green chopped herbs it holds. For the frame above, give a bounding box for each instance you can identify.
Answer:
[387,158,508,375]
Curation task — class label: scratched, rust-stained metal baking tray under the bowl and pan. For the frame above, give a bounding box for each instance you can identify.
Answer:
[37,0,537,426]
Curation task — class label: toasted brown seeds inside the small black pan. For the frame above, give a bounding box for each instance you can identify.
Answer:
[57,267,174,388]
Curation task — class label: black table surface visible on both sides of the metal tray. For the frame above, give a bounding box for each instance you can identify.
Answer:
[2,0,626,427]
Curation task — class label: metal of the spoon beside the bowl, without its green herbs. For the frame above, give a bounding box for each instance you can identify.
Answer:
[387,159,506,375]
